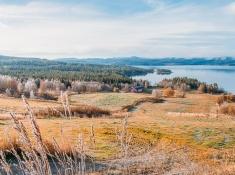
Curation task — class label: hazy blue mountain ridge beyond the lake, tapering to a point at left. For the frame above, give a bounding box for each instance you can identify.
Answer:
[56,57,235,66]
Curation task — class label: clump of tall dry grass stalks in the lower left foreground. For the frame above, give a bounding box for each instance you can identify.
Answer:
[0,96,92,175]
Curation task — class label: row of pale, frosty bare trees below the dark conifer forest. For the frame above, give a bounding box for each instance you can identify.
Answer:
[0,75,149,99]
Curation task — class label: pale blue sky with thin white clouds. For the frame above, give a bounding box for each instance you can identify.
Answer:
[0,0,235,58]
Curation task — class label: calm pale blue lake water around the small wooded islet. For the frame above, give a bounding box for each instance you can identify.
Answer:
[133,66,235,93]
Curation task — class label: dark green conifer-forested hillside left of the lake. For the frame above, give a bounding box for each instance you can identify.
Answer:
[0,56,153,83]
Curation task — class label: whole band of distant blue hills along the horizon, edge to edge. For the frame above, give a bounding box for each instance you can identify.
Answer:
[0,55,235,66]
